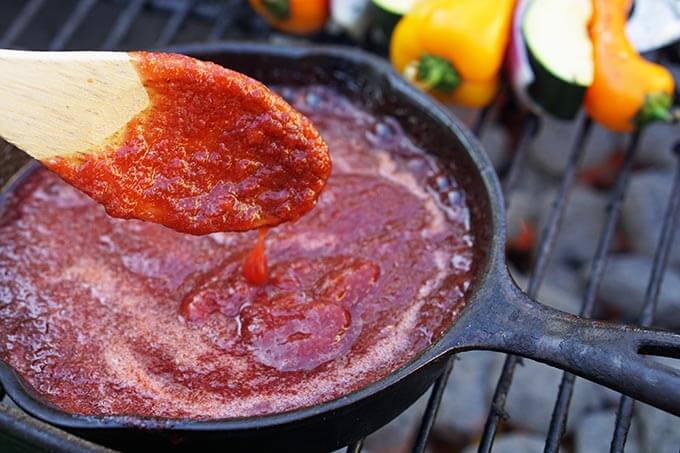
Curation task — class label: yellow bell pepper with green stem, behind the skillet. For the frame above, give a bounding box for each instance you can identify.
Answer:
[390,0,515,107]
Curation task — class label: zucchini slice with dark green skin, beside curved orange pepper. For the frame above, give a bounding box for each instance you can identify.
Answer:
[522,0,594,119]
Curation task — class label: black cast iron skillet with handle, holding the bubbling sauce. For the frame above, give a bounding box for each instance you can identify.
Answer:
[0,43,680,451]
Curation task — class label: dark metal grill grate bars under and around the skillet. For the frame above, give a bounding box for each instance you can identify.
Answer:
[0,0,680,453]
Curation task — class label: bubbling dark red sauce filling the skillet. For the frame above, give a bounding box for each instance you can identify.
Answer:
[0,87,474,419]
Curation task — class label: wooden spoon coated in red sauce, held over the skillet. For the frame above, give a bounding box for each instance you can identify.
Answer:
[0,50,331,234]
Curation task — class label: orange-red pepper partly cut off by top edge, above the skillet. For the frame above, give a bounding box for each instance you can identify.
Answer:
[250,0,330,35]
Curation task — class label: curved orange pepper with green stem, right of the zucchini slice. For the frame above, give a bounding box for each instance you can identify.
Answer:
[585,0,675,132]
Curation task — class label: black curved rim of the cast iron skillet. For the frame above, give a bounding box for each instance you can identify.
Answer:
[0,41,505,431]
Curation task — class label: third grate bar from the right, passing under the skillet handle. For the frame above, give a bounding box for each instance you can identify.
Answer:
[479,119,592,453]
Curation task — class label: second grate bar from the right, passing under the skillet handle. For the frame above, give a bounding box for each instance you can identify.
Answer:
[544,130,641,453]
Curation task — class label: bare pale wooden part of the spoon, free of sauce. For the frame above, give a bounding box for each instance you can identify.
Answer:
[0,50,149,159]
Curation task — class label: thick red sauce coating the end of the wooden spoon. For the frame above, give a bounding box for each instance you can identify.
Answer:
[45,52,331,235]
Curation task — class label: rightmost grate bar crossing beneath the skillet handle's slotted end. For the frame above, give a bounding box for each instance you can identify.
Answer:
[611,143,680,453]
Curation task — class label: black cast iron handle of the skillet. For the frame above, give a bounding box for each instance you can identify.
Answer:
[447,277,680,416]
